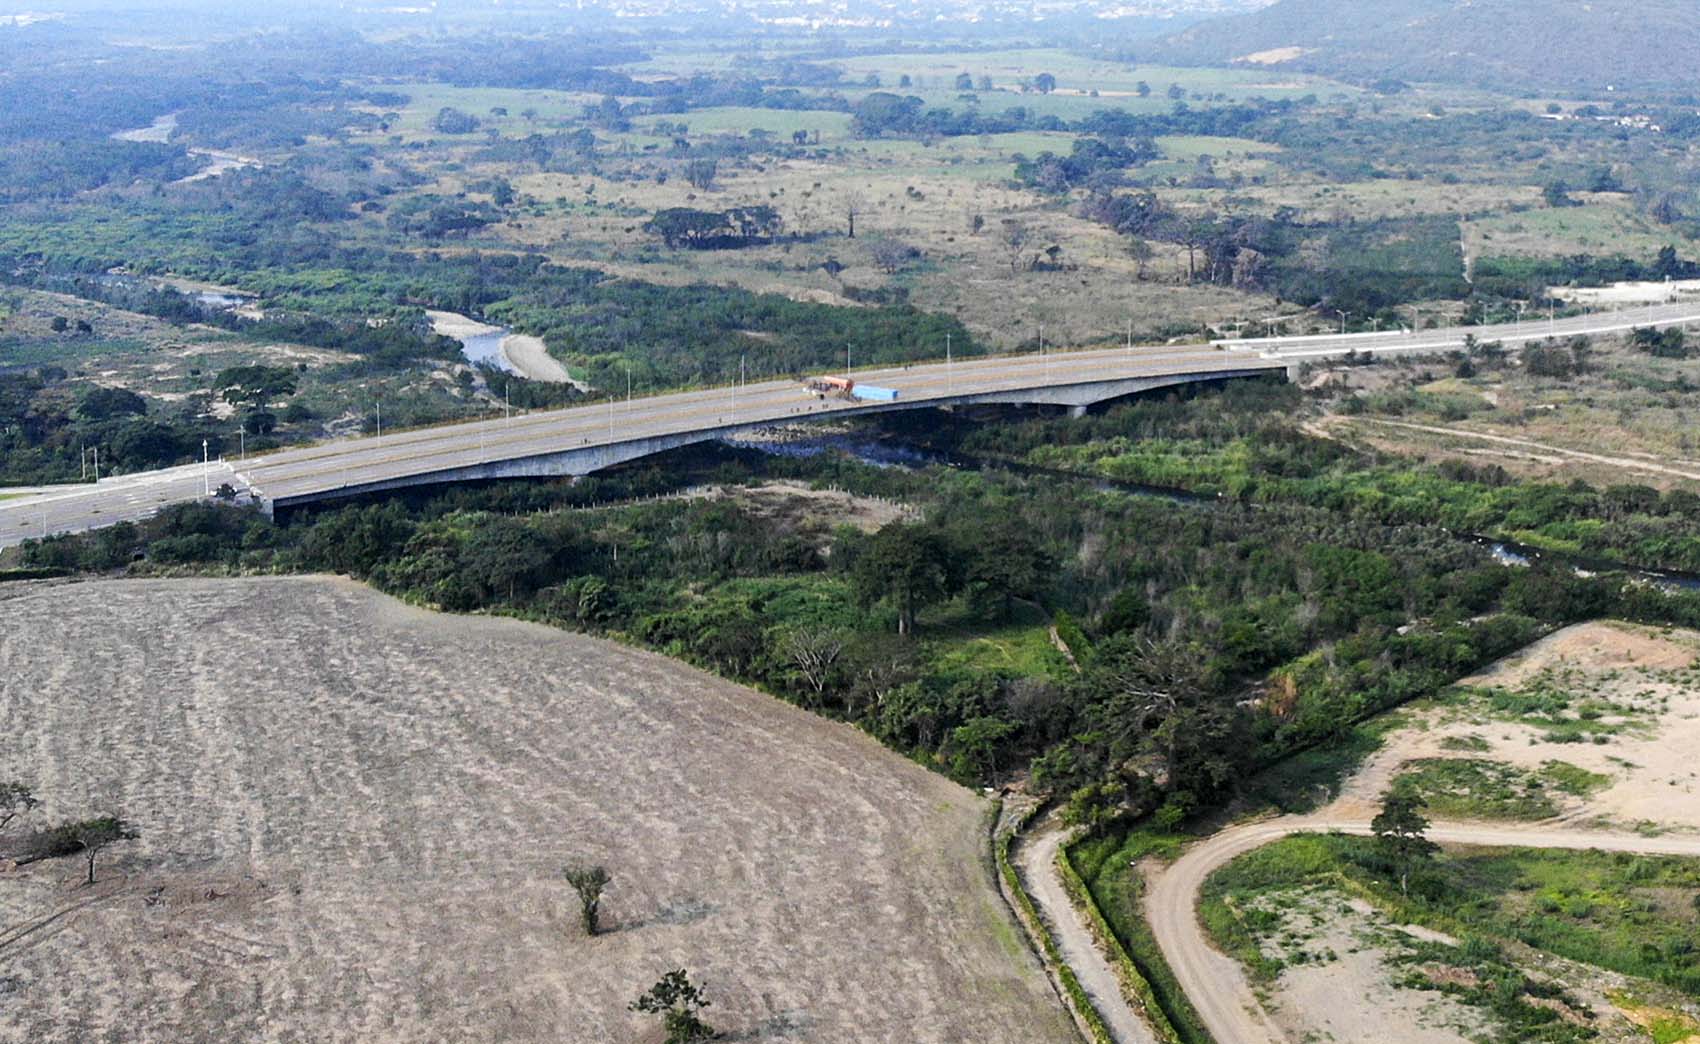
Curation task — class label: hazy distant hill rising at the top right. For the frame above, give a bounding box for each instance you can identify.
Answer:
[1146,0,1700,92]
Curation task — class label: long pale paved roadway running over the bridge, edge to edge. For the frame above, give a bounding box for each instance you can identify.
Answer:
[0,304,1700,548]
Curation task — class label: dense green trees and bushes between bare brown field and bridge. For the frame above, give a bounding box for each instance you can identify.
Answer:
[24,386,1697,823]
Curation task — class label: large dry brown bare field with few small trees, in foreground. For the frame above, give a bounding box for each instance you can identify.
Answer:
[0,580,1071,1044]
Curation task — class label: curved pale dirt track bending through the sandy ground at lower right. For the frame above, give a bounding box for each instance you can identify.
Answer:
[1146,816,1700,1044]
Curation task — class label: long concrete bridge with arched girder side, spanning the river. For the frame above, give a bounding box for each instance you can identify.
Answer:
[0,345,1287,546]
